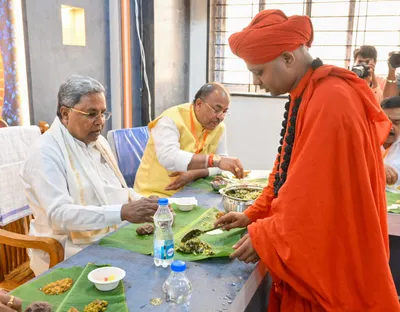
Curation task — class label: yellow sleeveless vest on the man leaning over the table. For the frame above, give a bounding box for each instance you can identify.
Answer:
[134,103,225,196]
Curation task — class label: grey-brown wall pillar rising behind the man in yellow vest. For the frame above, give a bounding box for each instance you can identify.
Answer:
[154,0,190,116]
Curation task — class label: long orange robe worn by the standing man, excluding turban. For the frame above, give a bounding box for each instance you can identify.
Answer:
[245,66,400,312]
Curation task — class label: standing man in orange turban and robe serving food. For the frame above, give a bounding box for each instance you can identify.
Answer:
[217,10,400,312]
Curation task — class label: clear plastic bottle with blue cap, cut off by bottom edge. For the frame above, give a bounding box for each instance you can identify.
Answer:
[163,260,192,311]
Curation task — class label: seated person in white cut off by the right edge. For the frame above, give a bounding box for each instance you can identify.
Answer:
[381,96,400,193]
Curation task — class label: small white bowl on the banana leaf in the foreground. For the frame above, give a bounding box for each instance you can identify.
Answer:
[88,267,125,291]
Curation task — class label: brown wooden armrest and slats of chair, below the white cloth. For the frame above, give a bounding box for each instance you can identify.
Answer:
[0,215,64,291]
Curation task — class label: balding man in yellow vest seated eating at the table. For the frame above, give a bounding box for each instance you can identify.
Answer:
[134,82,243,196]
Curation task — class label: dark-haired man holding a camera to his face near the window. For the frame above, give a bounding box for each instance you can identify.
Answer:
[353,45,398,103]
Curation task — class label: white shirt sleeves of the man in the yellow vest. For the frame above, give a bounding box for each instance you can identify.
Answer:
[151,117,228,176]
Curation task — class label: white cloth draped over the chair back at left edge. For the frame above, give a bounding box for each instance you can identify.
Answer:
[0,126,40,226]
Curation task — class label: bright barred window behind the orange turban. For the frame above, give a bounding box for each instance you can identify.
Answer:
[208,0,400,93]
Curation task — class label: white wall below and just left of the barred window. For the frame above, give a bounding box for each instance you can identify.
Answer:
[189,0,287,169]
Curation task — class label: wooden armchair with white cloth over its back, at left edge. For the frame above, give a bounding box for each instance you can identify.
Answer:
[0,126,64,290]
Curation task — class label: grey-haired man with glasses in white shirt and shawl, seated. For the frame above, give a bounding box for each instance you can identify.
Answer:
[20,75,158,275]
